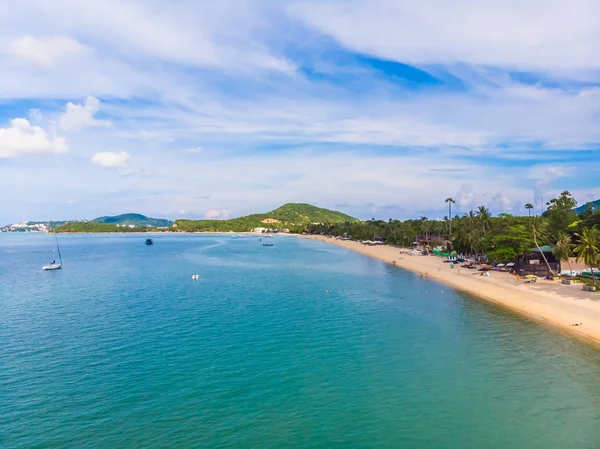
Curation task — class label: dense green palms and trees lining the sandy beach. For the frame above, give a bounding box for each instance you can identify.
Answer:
[306,191,600,269]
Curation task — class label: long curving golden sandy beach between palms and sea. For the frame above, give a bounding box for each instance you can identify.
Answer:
[301,236,600,346]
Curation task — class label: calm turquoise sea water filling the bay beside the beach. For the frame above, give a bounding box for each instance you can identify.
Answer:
[0,234,600,449]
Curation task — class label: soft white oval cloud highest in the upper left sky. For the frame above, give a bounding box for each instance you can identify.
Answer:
[8,36,90,67]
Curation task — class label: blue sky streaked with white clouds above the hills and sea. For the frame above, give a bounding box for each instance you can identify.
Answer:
[0,0,600,224]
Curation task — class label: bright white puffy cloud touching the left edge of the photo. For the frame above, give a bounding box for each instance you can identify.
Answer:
[0,118,67,158]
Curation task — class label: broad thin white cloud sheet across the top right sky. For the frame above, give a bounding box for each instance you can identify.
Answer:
[289,0,600,72]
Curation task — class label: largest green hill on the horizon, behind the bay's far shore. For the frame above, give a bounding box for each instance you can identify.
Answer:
[175,203,357,232]
